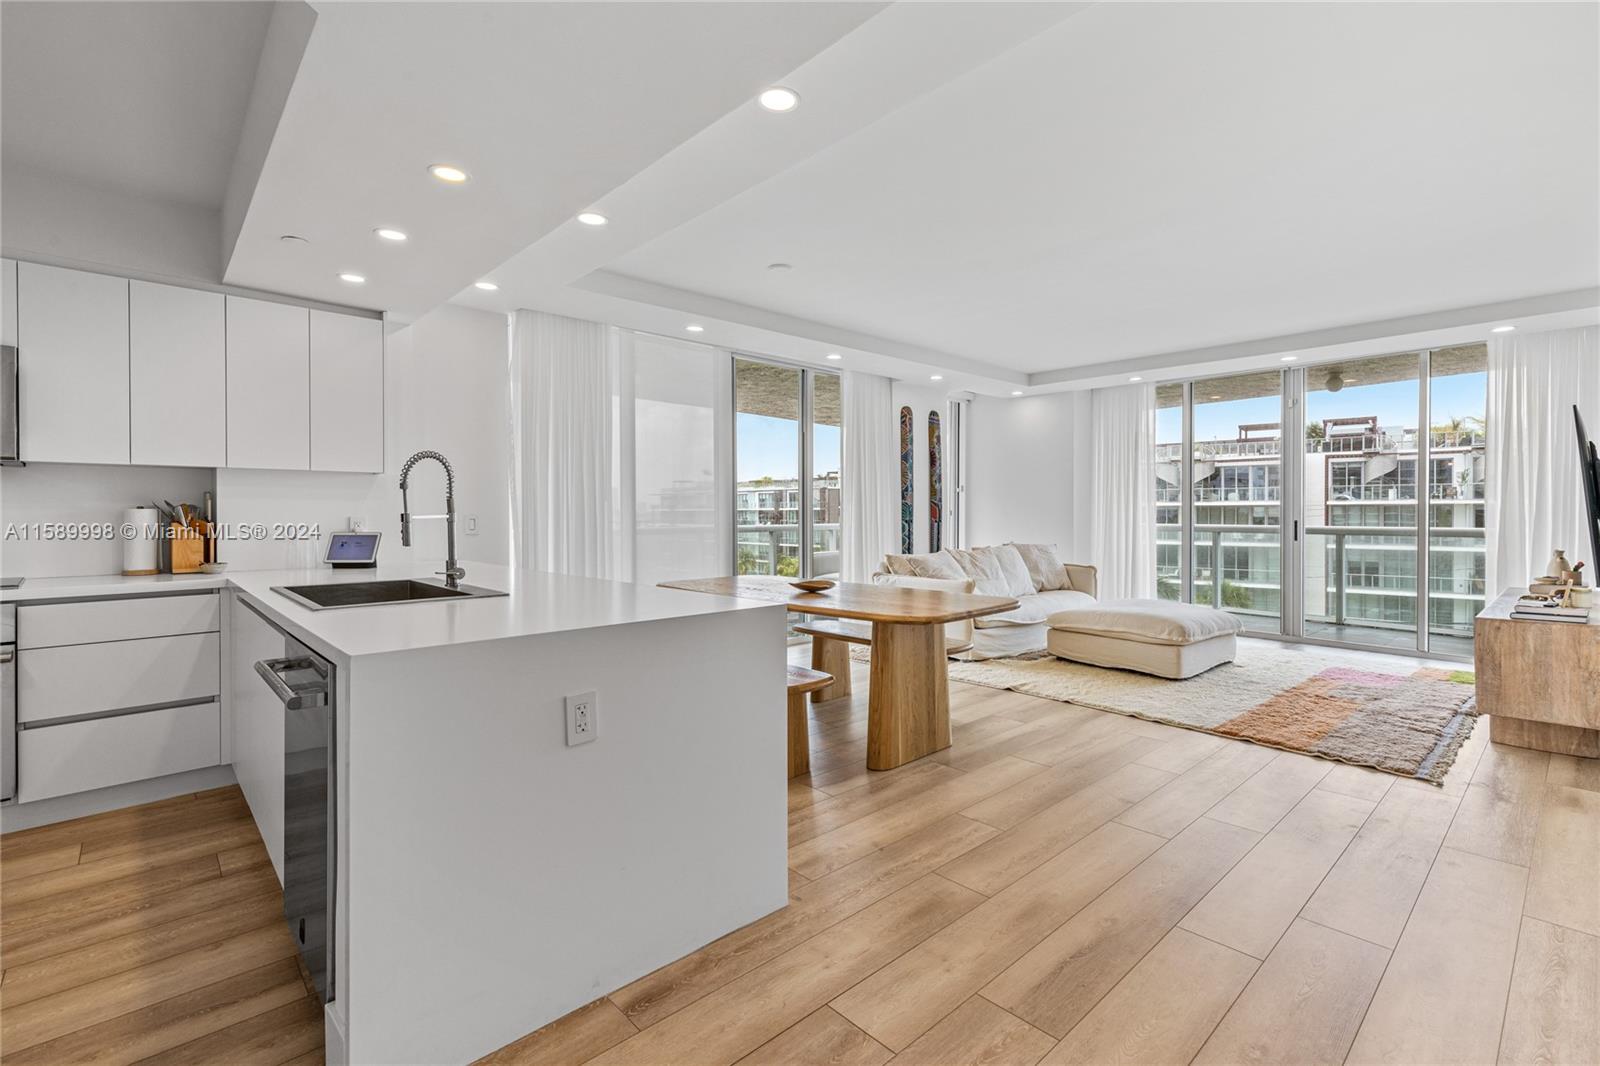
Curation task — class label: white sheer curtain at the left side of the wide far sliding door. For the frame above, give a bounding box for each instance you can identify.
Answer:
[1090,384,1155,600]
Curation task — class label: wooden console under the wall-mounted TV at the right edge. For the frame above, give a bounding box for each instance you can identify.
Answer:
[1474,589,1600,759]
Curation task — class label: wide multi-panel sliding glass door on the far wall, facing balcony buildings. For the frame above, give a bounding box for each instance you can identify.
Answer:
[1154,344,1486,656]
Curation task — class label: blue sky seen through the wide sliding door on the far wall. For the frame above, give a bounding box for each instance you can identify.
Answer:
[1155,373,1488,443]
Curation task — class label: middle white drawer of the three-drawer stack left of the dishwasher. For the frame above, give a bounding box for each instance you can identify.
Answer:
[16,632,221,722]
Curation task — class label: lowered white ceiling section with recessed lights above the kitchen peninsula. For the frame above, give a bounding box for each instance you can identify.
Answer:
[226,3,882,320]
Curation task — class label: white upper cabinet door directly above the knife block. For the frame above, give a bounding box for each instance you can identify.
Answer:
[128,282,227,466]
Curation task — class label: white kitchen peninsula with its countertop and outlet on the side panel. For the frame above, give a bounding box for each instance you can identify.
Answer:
[6,565,789,1063]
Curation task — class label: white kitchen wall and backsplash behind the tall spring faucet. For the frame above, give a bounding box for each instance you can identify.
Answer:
[216,304,510,581]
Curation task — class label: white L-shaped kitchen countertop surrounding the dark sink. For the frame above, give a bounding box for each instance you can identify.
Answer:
[0,563,782,659]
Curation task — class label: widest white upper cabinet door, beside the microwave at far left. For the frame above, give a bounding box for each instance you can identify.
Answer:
[18,262,128,463]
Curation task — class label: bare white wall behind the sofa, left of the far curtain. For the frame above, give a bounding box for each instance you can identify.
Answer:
[966,391,1093,562]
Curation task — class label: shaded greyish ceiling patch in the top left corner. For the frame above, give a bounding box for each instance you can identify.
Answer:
[0,0,272,210]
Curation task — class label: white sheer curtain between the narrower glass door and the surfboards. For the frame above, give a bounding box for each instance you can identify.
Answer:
[840,371,899,581]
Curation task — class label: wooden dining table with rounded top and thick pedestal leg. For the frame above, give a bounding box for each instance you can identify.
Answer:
[661,576,1018,770]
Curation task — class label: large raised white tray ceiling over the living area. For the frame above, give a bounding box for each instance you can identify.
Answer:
[600,3,1600,373]
